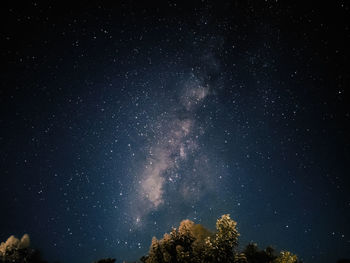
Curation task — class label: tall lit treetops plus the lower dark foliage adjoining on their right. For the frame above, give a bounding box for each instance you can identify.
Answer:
[141,215,298,263]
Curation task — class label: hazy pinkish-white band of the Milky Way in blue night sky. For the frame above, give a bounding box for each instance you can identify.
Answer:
[127,74,219,223]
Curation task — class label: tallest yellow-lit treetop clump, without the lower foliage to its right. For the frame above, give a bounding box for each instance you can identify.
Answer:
[141,215,239,263]
